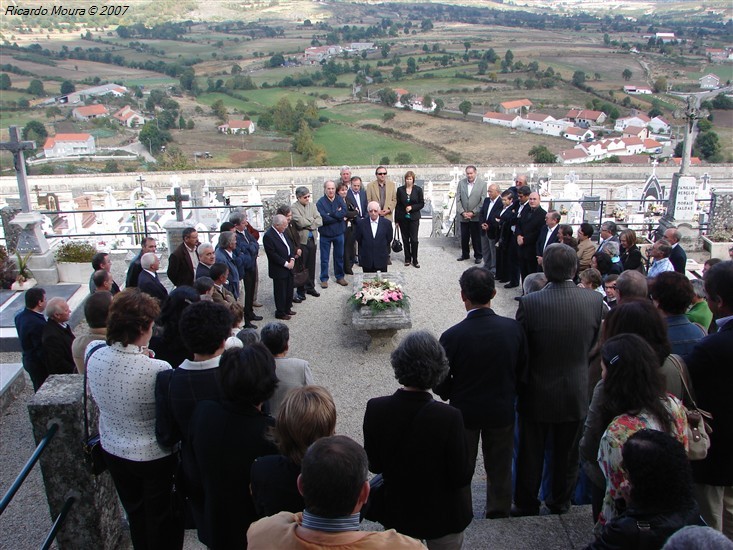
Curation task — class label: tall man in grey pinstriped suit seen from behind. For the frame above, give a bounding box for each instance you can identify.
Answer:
[512,243,604,516]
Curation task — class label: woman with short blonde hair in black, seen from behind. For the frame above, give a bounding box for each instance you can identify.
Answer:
[250,386,336,517]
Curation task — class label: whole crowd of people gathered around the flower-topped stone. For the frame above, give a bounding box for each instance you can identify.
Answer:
[11,166,733,549]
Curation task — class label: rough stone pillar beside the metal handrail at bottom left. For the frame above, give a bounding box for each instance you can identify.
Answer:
[28,374,129,548]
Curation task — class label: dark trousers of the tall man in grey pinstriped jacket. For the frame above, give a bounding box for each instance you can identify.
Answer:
[514,420,583,512]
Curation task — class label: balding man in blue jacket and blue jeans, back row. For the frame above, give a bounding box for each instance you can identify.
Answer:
[316,181,348,288]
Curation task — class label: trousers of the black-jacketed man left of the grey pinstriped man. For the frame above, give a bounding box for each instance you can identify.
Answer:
[466,422,514,518]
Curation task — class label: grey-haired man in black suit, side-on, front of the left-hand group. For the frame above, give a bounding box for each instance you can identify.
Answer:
[262,214,296,321]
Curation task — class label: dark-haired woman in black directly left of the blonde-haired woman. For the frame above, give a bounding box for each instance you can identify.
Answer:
[183,344,278,550]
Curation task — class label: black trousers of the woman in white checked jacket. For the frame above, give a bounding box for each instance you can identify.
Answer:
[104,451,183,550]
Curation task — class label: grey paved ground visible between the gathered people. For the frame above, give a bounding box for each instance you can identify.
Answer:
[0,234,592,549]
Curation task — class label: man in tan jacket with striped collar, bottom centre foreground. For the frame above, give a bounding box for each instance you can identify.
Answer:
[247,435,425,550]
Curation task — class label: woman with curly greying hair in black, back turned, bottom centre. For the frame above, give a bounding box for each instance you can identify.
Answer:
[364,331,473,549]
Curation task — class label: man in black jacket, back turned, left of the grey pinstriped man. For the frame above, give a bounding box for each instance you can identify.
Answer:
[435,267,527,518]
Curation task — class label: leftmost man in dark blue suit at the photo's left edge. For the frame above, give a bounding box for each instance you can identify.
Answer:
[15,287,48,391]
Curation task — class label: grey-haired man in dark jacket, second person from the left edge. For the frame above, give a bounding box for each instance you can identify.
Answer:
[41,297,76,375]
